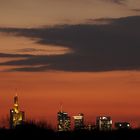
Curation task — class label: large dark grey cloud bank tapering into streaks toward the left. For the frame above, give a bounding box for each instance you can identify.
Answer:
[0,16,140,71]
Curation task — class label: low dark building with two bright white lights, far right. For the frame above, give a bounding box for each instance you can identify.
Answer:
[115,122,131,129]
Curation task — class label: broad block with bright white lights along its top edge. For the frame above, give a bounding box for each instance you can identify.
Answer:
[96,116,112,131]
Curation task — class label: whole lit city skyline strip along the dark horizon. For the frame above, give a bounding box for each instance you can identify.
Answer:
[0,93,140,129]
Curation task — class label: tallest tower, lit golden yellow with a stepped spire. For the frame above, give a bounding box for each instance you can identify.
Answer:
[10,95,25,128]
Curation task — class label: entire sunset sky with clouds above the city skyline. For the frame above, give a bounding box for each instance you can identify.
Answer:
[0,0,140,127]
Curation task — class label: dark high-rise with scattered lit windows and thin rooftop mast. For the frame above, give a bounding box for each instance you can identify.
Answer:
[57,106,71,131]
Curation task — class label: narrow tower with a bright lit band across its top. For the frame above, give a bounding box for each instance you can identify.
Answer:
[73,113,84,130]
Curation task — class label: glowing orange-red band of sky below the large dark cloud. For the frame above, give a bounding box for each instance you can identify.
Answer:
[0,71,140,126]
